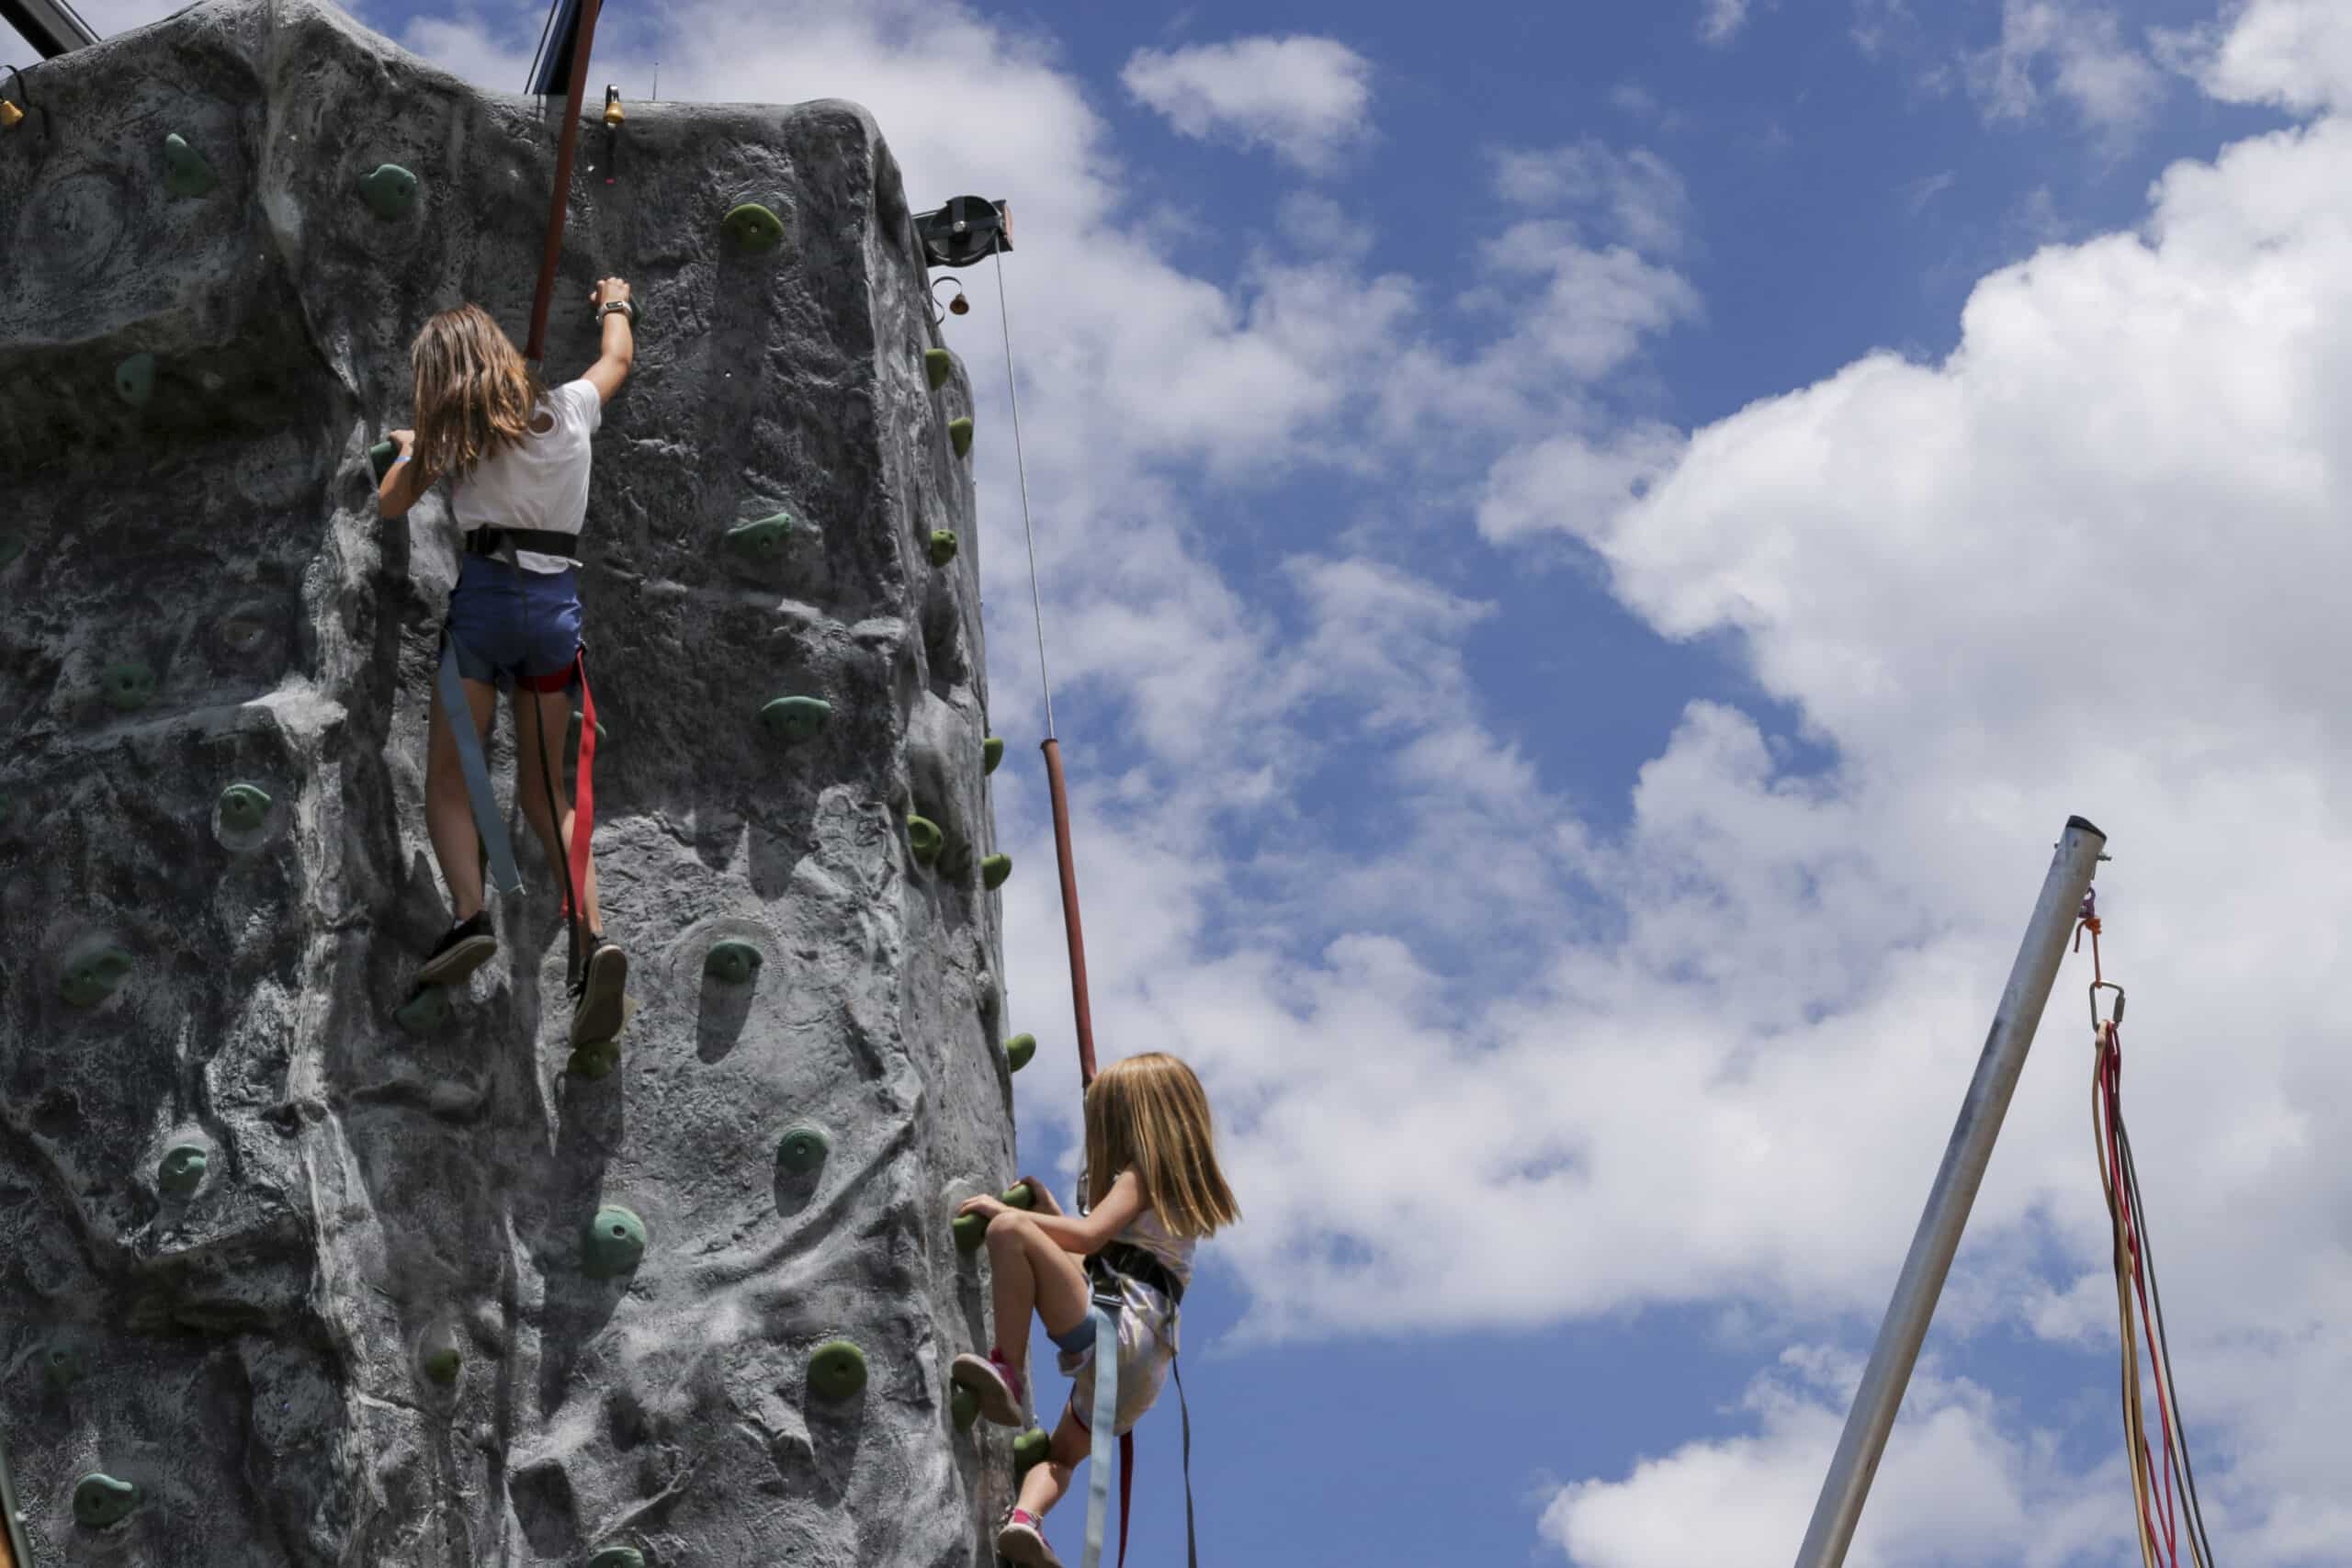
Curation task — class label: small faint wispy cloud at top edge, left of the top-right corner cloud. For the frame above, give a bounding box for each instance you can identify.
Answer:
[1969,0,2164,141]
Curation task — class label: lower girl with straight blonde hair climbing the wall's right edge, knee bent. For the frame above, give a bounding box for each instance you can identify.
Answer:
[950,1051,1242,1568]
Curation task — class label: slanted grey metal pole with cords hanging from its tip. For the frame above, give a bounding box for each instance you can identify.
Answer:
[1797,816,2108,1568]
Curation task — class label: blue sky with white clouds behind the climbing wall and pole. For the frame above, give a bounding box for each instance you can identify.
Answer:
[18,0,2352,1568]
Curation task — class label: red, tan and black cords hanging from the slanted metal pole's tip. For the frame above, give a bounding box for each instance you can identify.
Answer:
[2075,894,2213,1568]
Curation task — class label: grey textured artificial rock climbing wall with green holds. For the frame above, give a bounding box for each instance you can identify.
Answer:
[0,0,1012,1568]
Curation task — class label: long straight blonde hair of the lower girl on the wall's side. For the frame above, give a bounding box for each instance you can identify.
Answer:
[1087,1051,1242,1241]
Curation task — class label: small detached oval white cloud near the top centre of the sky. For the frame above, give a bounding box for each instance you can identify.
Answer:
[1120,35,1371,172]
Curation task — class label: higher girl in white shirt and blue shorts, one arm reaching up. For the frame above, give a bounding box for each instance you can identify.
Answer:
[377,277,635,1046]
